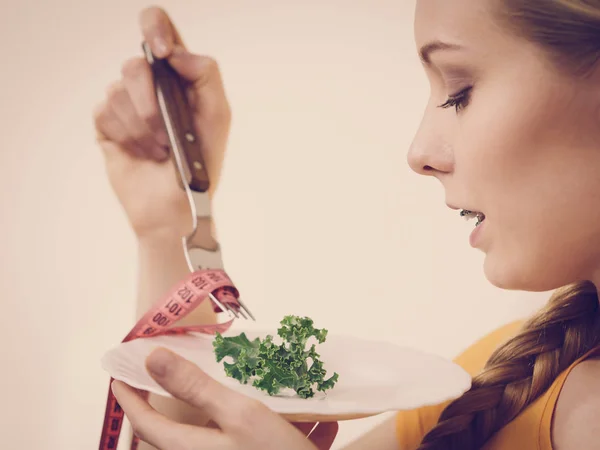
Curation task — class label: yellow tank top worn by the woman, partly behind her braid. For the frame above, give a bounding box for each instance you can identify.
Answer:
[396,322,598,450]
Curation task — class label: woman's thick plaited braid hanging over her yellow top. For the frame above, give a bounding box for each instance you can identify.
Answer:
[417,282,600,450]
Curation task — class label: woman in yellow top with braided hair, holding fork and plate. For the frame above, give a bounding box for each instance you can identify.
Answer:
[97,0,600,450]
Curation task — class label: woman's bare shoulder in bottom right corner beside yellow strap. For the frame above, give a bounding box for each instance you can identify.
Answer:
[552,358,600,450]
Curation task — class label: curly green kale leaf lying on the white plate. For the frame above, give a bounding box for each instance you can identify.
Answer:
[213,315,339,399]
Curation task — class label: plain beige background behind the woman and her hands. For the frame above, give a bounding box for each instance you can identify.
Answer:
[0,0,548,450]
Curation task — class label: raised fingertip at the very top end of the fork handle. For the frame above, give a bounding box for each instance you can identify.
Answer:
[139,7,183,58]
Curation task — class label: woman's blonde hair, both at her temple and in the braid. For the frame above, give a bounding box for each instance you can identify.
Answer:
[417,0,600,450]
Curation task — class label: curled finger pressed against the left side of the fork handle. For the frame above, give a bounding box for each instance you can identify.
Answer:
[121,58,170,147]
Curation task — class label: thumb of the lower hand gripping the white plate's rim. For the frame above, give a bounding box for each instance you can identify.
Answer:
[146,348,269,429]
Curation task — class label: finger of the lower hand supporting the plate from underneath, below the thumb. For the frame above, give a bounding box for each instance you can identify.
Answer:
[112,381,228,450]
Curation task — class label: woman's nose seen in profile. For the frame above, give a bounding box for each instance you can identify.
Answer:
[407,121,454,176]
